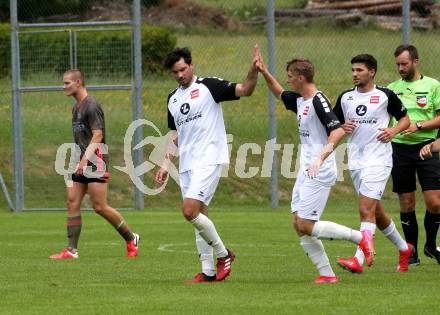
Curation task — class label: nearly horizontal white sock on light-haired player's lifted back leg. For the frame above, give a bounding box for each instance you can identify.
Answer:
[312,221,362,244]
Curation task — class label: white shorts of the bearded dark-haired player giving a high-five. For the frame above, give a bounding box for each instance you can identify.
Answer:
[179,165,222,206]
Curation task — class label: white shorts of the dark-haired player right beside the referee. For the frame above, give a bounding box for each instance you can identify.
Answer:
[350,166,391,200]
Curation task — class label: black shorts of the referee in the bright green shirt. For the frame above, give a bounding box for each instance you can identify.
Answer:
[391,139,440,193]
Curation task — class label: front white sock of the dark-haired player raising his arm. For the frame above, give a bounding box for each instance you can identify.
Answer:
[191,213,228,257]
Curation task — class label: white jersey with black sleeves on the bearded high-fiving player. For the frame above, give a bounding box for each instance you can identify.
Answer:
[168,78,239,173]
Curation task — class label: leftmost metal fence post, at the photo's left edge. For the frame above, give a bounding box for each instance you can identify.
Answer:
[10,0,24,211]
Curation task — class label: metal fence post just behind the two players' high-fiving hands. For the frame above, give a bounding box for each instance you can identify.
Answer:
[267,0,278,208]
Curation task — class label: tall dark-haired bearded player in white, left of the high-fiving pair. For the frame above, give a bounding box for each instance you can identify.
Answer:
[155,46,258,283]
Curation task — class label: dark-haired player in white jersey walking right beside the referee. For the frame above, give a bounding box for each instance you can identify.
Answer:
[334,54,413,273]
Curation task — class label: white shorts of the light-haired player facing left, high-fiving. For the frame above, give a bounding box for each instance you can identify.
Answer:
[291,173,332,221]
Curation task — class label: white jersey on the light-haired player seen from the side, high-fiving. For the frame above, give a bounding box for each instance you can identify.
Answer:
[281,91,340,185]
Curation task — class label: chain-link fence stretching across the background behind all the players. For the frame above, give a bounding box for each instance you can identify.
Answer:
[0,0,440,212]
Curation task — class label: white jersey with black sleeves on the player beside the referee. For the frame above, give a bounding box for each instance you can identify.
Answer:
[334,86,406,170]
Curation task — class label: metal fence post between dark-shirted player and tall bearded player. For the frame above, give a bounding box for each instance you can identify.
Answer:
[132,0,144,209]
